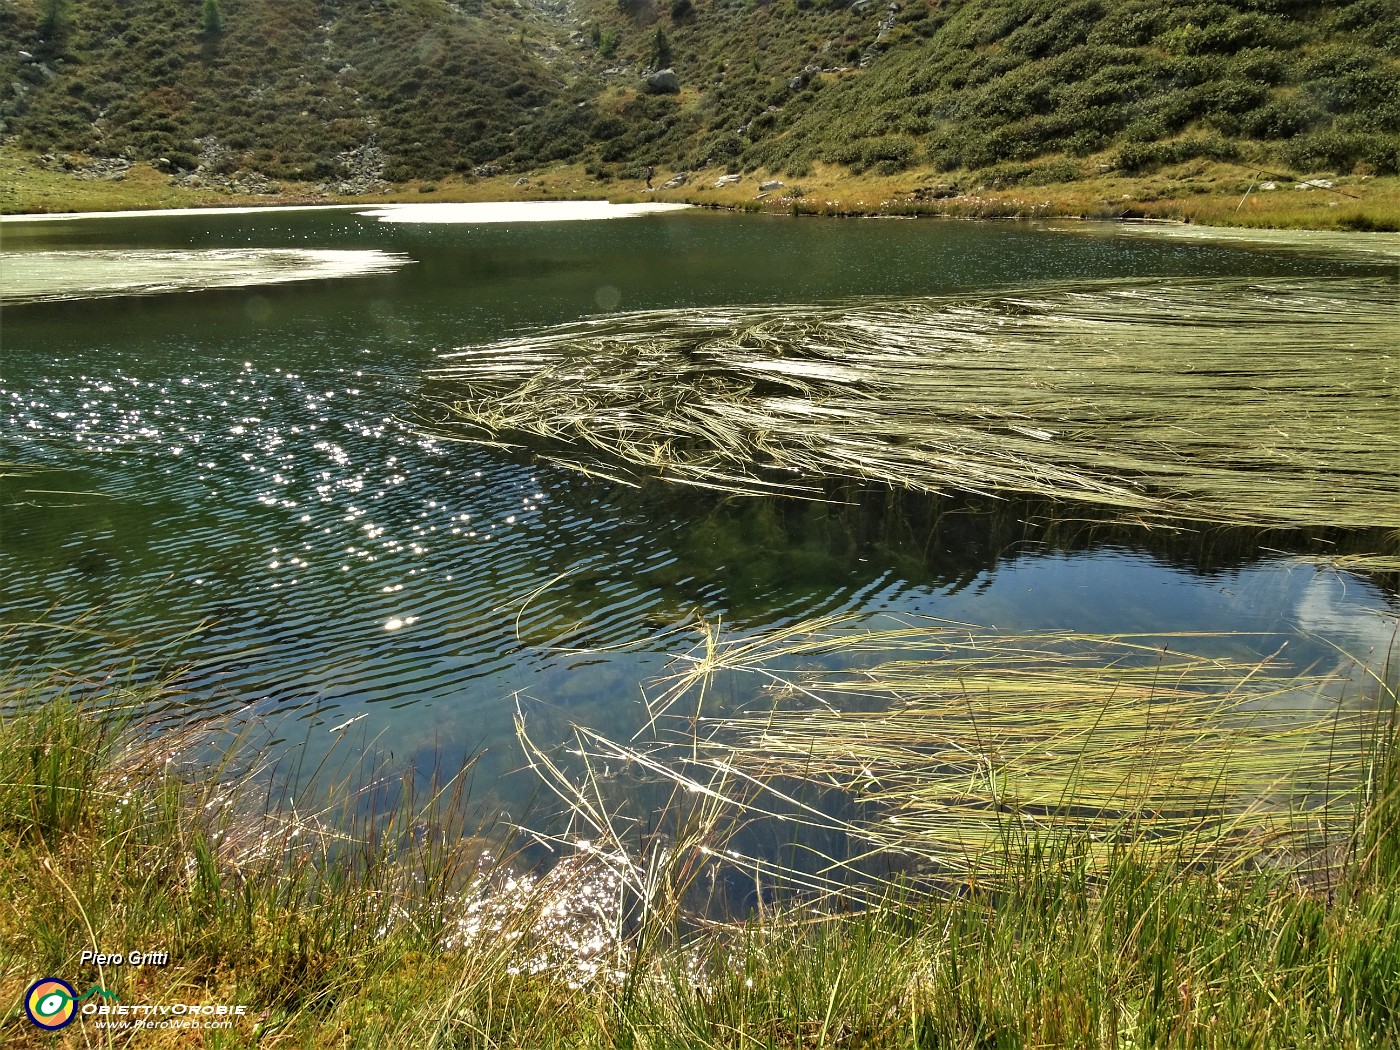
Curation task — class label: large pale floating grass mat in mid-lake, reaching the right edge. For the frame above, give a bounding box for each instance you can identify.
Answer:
[423,279,1400,534]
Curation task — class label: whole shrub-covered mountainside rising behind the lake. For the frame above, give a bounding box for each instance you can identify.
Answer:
[0,0,1400,192]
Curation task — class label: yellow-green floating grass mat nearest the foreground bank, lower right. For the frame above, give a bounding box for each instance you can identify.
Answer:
[562,619,1396,888]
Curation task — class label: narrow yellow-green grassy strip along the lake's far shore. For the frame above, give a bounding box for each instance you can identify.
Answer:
[8,150,1400,234]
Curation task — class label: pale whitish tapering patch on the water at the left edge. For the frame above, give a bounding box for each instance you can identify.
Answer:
[0,248,413,305]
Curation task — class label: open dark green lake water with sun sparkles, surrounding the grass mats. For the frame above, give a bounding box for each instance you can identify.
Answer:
[0,210,1394,798]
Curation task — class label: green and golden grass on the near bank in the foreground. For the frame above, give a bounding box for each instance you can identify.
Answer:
[0,641,1400,1050]
